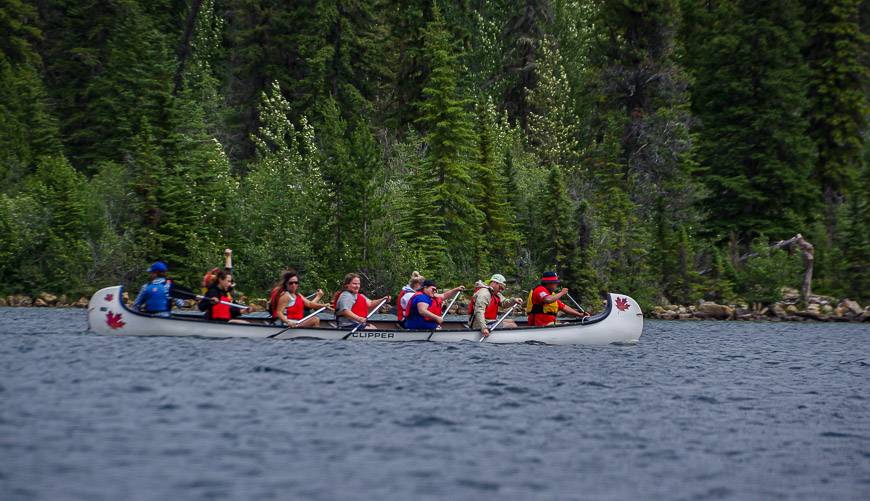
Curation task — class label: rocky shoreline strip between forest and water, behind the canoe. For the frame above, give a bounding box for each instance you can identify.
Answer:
[0,290,870,322]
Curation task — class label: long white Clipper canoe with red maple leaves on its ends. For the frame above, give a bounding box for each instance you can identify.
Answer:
[88,286,643,345]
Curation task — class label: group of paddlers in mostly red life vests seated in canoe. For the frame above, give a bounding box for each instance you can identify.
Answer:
[133,249,588,337]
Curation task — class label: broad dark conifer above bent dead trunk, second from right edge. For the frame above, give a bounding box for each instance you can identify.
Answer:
[686,0,817,242]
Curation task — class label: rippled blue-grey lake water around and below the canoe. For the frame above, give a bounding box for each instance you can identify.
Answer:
[0,308,870,501]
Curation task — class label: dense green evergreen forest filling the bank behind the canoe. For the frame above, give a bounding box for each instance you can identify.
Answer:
[0,0,870,305]
